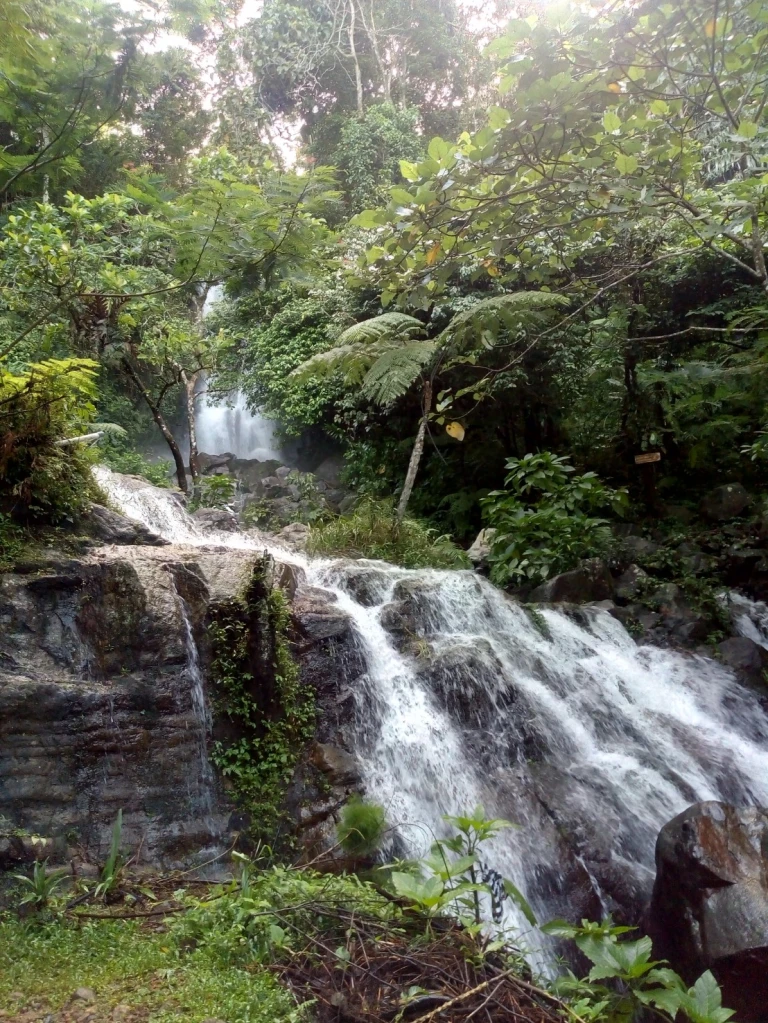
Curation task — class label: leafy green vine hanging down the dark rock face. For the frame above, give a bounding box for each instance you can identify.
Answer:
[209,567,315,835]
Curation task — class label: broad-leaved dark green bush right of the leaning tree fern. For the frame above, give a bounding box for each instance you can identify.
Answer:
[482,451,627,586]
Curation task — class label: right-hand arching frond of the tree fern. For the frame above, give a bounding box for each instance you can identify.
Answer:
[440,292,569,352]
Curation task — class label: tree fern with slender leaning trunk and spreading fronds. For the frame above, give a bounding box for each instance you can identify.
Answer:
[291,292,563,521]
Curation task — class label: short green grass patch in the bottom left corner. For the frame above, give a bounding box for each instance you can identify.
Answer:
[0,918,306,1023]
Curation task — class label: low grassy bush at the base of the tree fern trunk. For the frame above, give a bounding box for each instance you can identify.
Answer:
[308,500,469,569]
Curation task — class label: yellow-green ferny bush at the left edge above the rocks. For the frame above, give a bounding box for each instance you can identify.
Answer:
[0,359,97,523]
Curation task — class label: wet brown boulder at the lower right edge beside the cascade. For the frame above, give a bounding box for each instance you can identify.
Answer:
[649,802,768,1023]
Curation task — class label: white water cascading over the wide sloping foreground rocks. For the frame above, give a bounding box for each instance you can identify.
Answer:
[99,470,768,949]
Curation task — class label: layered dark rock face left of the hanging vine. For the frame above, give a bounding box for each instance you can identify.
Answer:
[0,546,263,864]
